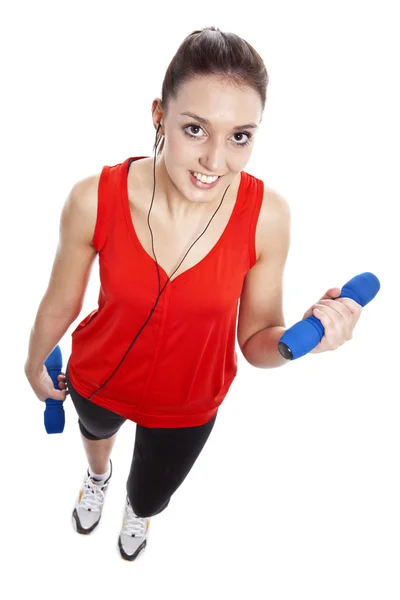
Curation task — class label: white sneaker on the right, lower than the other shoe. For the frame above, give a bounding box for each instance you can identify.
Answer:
[118,496,150,560]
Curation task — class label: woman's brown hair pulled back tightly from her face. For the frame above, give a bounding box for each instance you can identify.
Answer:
[153,26,269,154]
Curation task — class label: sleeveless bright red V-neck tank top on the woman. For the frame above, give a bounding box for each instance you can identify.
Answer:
[68,156,264,427]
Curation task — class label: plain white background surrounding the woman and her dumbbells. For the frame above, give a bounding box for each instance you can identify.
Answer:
[0,0,400,600]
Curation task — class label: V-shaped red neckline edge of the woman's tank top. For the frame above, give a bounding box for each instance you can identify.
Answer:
[121,156,244,284]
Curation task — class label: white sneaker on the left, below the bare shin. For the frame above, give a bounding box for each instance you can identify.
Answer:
[72,459,112,534]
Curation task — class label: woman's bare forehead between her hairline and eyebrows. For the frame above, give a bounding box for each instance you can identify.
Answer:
[171,75,262,123]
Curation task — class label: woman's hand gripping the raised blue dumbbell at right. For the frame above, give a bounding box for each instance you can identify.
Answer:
[302,288,362,354]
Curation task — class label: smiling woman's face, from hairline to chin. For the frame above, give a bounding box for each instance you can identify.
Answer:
[154,75,262,201]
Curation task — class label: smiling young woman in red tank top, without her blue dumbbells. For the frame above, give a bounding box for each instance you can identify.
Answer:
[25,27,361,560]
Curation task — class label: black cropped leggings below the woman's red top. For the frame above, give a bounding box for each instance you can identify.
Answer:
[65,365,217,517]
